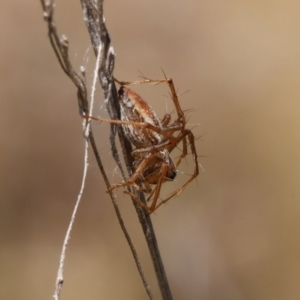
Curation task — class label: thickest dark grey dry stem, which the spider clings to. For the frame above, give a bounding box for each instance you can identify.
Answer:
[81,0,172,300]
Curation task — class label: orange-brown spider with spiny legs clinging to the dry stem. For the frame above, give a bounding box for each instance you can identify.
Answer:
[87,76,199,213]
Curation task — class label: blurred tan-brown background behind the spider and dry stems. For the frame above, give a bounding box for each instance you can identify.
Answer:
[0,0,300,300]
